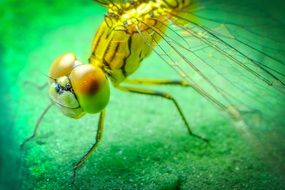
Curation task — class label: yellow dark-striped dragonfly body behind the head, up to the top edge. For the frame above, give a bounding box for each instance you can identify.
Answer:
[89,0,190,86]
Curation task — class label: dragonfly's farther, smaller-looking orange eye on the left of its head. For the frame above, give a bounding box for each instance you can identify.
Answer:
[49,53,82,82]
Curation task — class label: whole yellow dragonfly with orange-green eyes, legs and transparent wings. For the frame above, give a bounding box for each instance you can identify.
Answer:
[22,0,285,183]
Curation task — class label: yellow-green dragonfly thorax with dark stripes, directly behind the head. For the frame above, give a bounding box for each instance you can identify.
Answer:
[90,5,168,86]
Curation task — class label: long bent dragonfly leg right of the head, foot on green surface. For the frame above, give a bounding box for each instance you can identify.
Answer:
[117,86,208,142]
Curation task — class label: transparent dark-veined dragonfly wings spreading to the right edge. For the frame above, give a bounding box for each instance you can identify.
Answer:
[135,0,285,171]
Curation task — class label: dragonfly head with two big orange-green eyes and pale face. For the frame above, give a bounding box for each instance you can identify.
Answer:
[49,53,110,118]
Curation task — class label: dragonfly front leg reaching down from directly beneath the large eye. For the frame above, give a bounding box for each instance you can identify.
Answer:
[72,110,106,184]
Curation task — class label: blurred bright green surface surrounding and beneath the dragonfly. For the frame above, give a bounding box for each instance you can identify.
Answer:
[0,0,285,189]
